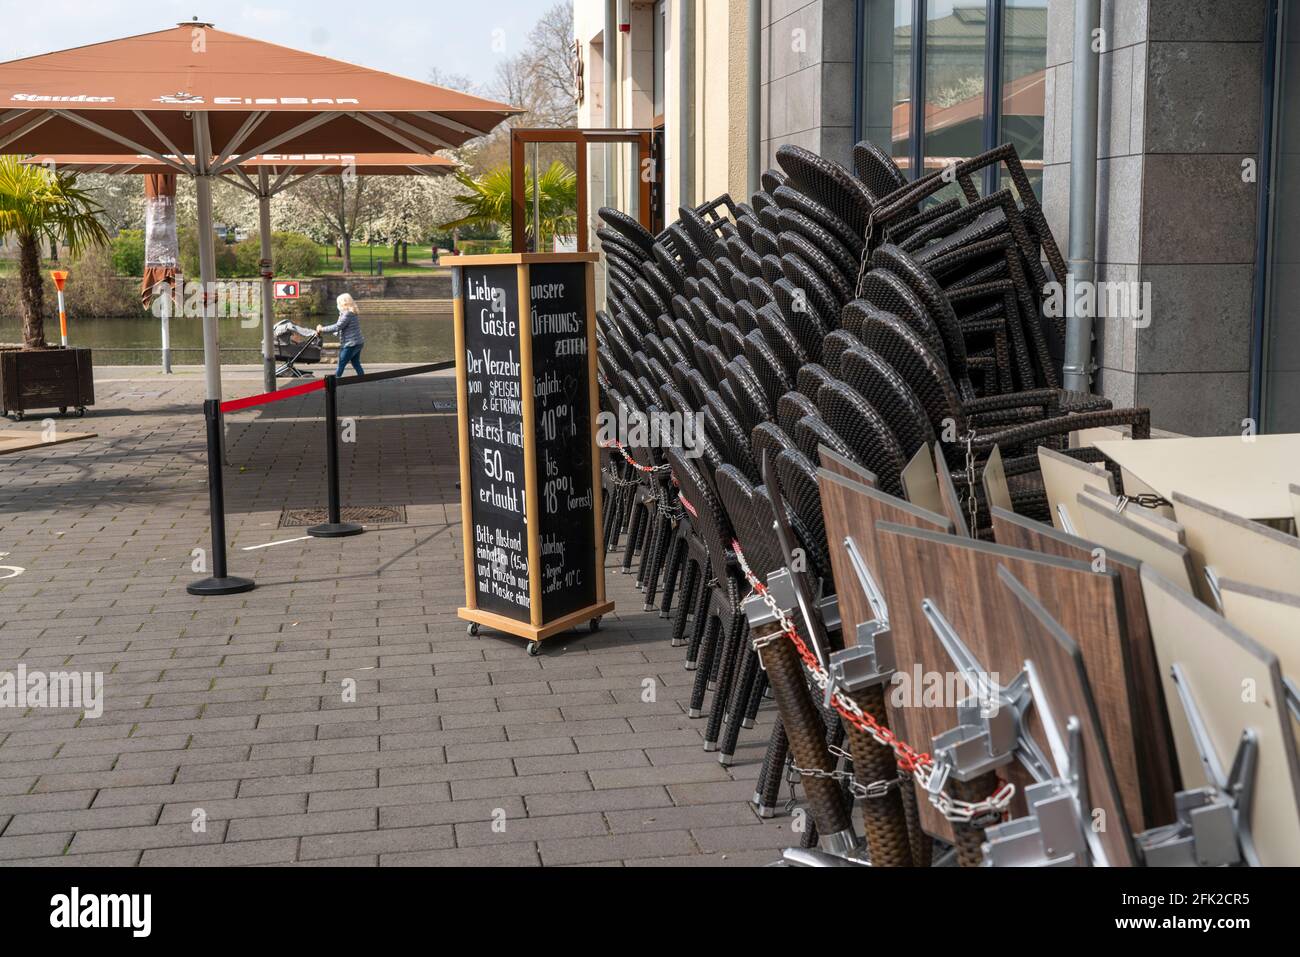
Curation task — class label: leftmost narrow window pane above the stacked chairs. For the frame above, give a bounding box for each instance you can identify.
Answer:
[862,0,911,176]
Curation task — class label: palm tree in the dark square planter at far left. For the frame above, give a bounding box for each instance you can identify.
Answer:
[0,156,108,348]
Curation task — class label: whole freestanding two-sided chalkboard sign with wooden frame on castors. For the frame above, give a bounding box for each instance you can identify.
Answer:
[455,254,614,642]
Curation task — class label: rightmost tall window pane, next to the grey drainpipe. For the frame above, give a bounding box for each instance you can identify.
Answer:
[998,0,1048,200]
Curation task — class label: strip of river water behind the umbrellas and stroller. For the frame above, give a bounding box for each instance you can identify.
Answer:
[0,313,455,369]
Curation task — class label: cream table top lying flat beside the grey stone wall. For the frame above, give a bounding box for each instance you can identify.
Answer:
[1097,433,1300,521]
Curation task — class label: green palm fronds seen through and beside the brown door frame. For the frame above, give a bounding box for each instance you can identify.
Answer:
[441,161,577,250]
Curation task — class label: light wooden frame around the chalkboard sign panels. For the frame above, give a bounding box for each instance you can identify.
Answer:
[454,252,614,650]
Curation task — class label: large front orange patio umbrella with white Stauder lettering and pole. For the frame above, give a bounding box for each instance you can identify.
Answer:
[0,21,520,399]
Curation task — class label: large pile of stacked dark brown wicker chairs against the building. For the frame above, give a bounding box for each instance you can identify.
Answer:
[597,143,1149,861]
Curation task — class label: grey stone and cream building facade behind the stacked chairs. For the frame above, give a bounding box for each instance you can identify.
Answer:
[576,0,1300,434]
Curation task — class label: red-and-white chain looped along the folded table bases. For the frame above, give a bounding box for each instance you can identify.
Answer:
[732,541,1015,823]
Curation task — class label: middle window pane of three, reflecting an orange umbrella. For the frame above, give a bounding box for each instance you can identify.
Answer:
[926,0,988,180]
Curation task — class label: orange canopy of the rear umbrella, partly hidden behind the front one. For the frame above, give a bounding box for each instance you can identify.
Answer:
[23,153,456,177]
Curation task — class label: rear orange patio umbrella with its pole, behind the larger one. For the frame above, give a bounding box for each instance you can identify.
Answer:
[23,153,456,393]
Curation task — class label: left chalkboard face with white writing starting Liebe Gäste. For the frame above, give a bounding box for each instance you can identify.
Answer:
[460,265,532,622]
